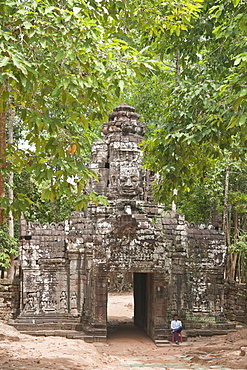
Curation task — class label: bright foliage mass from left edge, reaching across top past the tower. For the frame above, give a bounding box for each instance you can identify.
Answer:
[0,0,205,223]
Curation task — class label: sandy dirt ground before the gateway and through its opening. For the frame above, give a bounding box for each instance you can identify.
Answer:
[0,294,247,370]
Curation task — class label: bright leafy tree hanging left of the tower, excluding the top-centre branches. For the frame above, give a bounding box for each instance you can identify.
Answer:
[0,1,137,223]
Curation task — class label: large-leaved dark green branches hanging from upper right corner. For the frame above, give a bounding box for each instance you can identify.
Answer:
[140,1,246,200]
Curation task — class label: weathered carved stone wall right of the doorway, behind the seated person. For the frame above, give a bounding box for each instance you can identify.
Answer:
[162,212,226,324]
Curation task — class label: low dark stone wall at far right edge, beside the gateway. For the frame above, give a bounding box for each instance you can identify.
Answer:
[224,281,247,325]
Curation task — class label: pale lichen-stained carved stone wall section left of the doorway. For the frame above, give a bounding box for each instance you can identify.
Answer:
[20,220,83,316]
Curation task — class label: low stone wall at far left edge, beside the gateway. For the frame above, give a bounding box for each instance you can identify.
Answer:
[0,279,20,321]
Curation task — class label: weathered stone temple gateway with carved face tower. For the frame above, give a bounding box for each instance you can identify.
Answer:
[15,104,233,343]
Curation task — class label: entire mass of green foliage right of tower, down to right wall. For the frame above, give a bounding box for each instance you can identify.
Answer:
[125,0,247,280]
